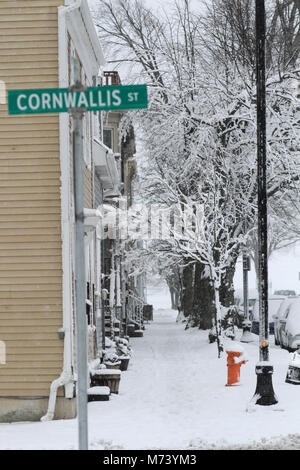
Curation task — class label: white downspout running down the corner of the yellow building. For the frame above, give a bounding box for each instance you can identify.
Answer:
[41,2,74,421]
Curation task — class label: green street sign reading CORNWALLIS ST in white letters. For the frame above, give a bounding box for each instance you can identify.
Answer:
[8,85,148,115]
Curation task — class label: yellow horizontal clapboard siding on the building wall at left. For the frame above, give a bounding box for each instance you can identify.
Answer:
[0,0,64,397]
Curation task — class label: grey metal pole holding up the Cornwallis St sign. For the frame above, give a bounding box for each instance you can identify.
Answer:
[71,59,88,450]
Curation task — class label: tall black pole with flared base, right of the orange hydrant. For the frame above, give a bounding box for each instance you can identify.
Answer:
[255,0,277,405]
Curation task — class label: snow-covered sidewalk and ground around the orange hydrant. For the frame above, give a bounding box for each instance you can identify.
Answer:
[0,310,300,450]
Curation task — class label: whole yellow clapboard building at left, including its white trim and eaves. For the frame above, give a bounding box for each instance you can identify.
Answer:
[0,0,118,421]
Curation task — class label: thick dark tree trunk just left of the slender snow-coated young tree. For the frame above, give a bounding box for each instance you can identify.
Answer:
[192,263,215,330]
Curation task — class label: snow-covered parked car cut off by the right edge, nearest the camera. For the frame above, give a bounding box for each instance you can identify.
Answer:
[281,297,300,351]
